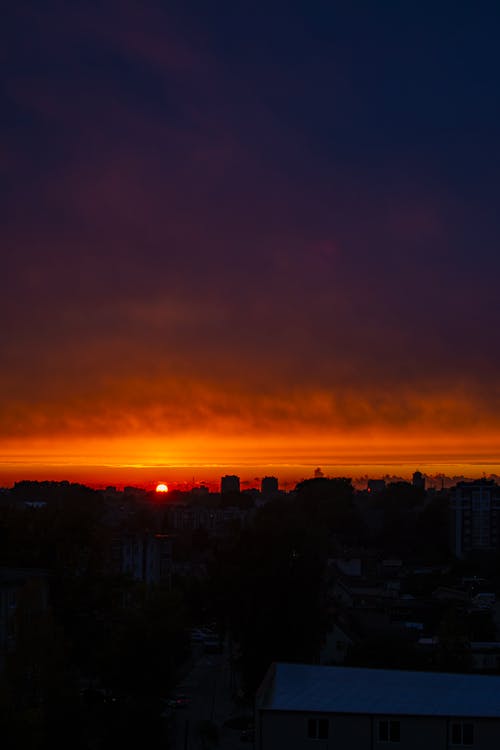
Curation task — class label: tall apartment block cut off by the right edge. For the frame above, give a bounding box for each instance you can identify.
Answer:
[451,479,500,558]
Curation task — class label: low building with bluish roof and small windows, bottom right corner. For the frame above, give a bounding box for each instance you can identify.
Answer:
[255,664,500,750]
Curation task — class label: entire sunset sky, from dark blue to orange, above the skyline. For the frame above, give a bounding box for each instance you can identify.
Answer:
[0,0,500,484]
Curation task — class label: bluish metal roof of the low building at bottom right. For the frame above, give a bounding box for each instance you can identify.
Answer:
[257,664,500,718]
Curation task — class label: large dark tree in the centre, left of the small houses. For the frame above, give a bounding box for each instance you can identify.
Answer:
[211,501,328,694]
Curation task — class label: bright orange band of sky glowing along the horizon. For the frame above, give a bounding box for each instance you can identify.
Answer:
[0,429,500,489]
